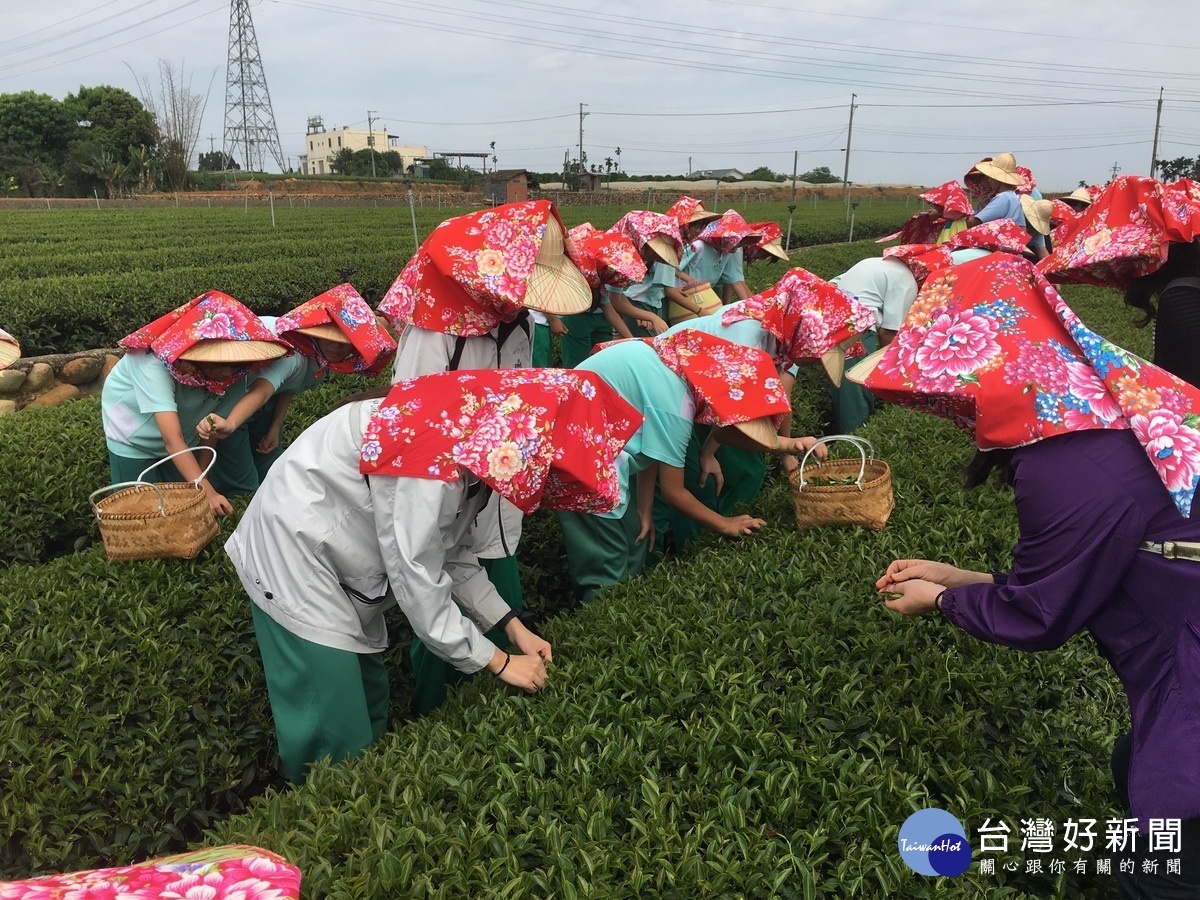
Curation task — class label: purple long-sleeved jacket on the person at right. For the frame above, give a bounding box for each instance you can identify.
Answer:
[942,431,1200,827]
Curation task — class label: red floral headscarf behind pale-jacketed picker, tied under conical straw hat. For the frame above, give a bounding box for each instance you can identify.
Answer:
[379,200,592,337]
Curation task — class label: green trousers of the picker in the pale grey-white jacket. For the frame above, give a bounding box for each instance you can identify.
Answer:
[251,604,389,785]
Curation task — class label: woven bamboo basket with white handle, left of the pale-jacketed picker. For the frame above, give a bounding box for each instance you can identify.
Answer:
[90,448,221,562]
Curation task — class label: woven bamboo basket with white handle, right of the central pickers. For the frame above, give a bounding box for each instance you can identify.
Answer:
[787,434,895,532]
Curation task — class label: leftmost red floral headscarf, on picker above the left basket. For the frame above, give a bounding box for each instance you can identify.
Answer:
[120,290,292,395]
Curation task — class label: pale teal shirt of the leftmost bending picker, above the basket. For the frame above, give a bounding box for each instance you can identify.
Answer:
[100,350,257,460]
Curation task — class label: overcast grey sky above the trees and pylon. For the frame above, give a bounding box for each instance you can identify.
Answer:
[0,0,1200,191]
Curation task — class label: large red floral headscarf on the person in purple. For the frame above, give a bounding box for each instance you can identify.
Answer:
[850,253,1200,515]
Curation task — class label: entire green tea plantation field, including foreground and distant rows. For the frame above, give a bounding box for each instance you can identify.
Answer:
[0,200,1148,900]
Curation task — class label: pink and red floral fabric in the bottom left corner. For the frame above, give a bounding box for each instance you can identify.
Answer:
[0,846,300,900]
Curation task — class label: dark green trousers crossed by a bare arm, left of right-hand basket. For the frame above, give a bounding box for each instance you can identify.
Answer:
[654,425,767,553]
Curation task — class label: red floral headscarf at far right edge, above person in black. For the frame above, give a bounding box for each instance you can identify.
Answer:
[1038,175,1200,288]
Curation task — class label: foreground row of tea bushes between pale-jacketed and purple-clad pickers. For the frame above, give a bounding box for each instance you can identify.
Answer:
[201,408,1127,900]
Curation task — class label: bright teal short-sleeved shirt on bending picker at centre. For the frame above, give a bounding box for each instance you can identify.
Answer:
[577,341,696,518]
